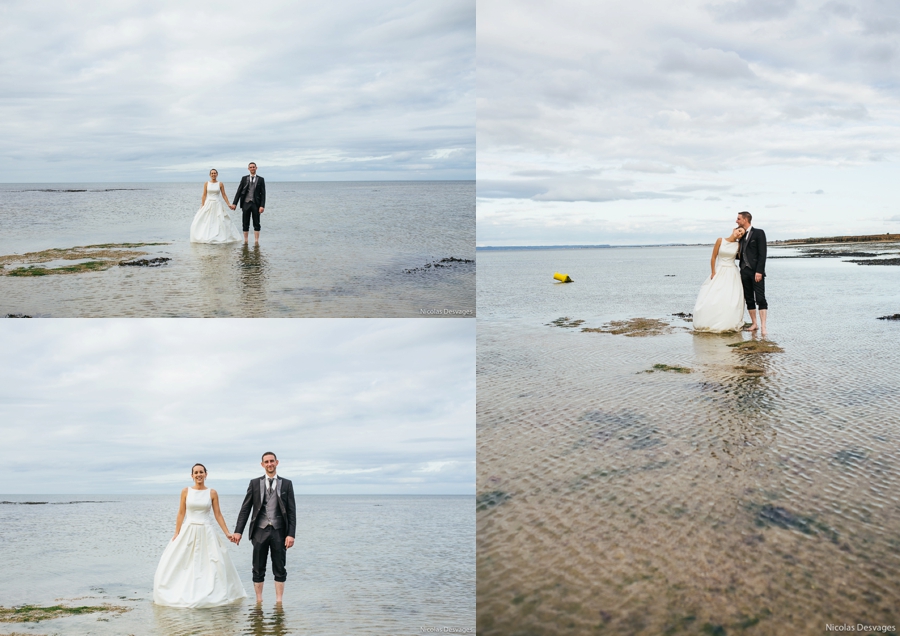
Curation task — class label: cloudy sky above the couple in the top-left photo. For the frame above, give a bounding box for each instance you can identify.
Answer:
[0,0,475,183]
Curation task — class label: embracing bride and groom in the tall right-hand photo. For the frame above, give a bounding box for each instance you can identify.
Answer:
[694,212,769,337]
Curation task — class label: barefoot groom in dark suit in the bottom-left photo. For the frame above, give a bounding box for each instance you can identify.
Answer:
[232,453,297,603]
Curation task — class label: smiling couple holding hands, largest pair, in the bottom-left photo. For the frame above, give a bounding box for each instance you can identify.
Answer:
[153,453,297,608]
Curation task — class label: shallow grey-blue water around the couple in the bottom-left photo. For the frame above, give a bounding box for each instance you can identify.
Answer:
[0,493,475,636]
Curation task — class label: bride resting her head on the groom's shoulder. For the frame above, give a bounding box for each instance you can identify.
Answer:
[694,227,744,333]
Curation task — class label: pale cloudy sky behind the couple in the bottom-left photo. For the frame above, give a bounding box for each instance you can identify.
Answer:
[0,319,475,494]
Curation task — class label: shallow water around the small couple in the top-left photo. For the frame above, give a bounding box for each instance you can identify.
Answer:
[0,181,475,318]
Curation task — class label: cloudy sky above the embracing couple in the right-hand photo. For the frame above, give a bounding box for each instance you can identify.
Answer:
[477,0,900,245]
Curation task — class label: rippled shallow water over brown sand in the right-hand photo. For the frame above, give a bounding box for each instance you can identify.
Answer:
[477,247,900,635]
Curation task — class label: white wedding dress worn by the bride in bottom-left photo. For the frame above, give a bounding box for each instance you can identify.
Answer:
[153,488,247,607]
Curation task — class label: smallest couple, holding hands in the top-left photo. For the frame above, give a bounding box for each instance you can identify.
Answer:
[191,161,266,244]
